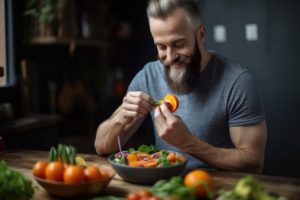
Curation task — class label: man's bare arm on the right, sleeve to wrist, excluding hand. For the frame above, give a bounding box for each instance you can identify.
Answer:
[184,122,267,173]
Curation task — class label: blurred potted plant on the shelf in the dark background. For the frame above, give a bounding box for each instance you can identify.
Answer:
[24,0,66,39]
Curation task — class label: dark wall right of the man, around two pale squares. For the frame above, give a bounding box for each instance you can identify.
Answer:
[199,0,300,177]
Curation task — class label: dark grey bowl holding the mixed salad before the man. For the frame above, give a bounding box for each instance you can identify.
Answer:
[108,152,187,185]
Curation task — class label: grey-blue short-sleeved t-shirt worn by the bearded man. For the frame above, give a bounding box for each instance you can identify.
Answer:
[128,53,264,168]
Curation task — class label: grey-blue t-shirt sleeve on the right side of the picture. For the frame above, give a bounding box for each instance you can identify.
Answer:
[228,71,265,127]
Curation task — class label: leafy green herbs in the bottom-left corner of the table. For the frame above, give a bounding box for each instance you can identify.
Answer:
[0,160,34,200]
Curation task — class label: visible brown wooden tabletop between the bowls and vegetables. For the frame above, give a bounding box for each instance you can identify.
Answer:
[0,150,300,200]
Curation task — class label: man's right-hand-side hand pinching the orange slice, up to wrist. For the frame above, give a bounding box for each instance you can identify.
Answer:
[154,104,192,148]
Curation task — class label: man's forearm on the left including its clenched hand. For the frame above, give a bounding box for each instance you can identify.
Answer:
[95,92,153,155]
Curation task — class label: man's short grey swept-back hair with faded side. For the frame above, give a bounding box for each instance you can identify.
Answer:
[147,0,201,31]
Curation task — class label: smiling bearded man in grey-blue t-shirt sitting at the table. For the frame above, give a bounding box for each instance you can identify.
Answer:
[95,0,267,173]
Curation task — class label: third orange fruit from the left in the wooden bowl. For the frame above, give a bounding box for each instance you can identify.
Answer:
[64,165,85,183]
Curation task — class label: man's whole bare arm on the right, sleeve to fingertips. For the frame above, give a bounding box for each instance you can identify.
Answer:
[155,105,267,173]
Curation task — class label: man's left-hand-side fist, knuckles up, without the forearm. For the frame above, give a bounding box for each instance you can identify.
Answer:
[116,92,153,125]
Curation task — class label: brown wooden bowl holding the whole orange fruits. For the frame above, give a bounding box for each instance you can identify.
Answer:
[34,166,115,197]
